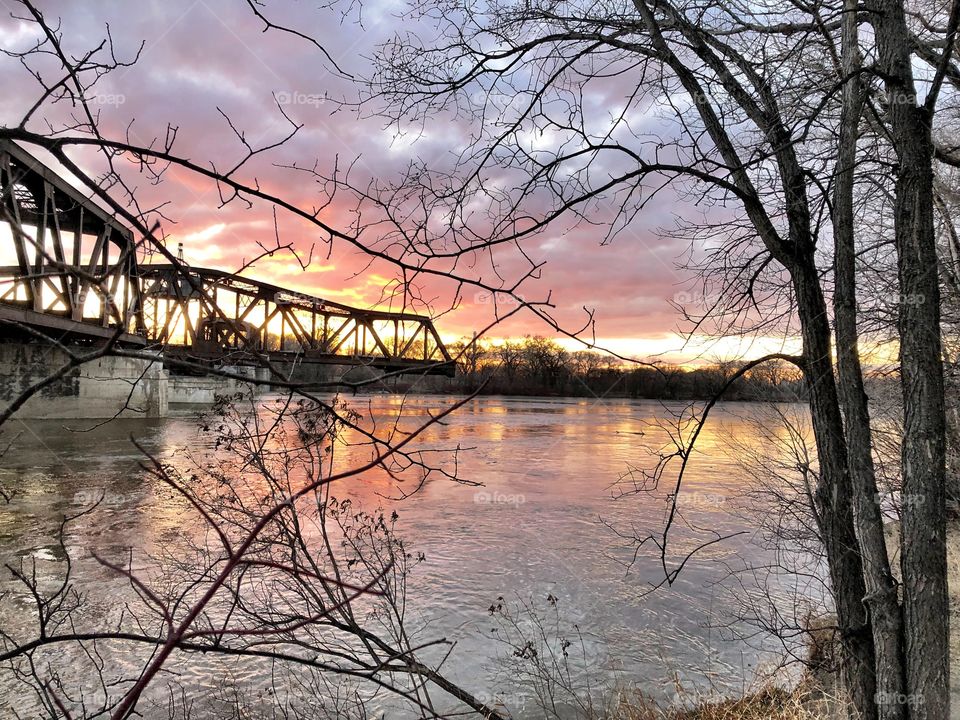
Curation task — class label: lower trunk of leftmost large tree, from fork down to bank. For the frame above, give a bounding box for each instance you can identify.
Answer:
[792,256,878,720]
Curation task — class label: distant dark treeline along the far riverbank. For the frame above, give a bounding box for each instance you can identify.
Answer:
[436,337,804,401]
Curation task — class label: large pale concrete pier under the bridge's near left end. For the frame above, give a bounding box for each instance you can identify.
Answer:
[0,342,168,420]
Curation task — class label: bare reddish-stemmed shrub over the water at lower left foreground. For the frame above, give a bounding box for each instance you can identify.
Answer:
[0,390,506,718]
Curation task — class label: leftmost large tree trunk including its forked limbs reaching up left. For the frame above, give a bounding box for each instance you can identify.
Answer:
[634,5,877,720]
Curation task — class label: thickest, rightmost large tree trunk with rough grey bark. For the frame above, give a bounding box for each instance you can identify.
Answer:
[870,0,950,720]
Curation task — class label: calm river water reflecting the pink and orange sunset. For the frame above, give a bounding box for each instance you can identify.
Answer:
[0,396,824,717]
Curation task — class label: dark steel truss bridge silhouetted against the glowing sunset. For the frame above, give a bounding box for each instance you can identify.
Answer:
[0,140,454,375]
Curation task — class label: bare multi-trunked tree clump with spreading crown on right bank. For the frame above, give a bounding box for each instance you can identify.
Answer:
[366,0,958,718]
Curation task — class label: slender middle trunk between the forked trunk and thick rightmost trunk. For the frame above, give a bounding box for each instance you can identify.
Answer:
[832,0,908,720]
